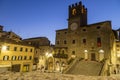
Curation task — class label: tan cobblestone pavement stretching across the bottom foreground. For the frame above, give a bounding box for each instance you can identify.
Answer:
[0,71,120,80]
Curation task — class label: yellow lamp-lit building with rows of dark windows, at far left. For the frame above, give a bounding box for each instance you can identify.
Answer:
[0,38,34,72]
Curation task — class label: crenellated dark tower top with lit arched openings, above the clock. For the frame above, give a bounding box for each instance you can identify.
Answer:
[68,1,87,26]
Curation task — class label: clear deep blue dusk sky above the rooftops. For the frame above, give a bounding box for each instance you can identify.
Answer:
[0,0,120,44]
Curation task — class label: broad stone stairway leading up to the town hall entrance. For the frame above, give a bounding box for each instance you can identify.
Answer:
[66,60,103,76]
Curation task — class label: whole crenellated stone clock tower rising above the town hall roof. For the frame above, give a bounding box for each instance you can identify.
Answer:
[68,2,87,30]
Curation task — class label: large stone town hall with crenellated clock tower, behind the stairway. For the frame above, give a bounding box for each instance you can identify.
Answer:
[55,2,116,74]
